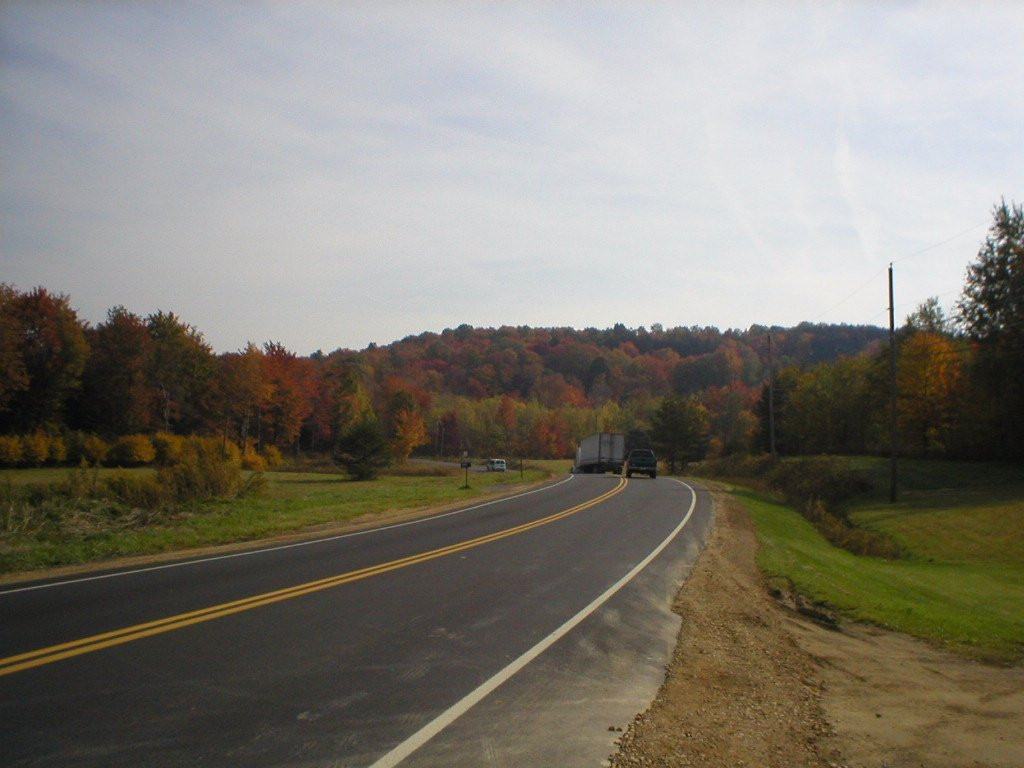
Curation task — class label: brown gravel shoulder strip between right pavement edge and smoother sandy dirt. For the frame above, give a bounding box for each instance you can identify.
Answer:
[611,492,829,768]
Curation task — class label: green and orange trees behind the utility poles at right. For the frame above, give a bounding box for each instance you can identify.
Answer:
[756,202,1024,461]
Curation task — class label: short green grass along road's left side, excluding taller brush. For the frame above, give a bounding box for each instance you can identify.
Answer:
[0,467,548,572]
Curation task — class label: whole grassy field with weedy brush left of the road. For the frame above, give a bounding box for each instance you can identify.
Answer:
[0,456,549,573]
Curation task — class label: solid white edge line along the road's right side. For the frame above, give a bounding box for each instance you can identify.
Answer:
[370,478,697,768]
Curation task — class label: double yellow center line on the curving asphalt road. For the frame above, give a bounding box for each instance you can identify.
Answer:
[0,478,626,677]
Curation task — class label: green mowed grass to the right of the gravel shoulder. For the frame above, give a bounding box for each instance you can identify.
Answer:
[735,460,1024,662]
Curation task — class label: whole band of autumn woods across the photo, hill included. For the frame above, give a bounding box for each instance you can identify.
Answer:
[0,202,1024,461]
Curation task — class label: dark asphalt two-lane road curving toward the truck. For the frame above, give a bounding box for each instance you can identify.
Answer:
[0,476,711,767]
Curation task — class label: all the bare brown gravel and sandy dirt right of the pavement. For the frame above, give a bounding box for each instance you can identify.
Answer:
[611,494,1024,768]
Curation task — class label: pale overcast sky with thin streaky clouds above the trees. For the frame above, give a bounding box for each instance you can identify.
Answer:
[0,0,1024,354]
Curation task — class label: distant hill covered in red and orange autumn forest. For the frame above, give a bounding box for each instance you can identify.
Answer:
[329,323,887,407]
